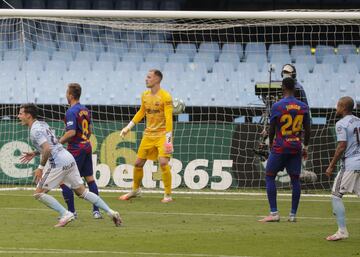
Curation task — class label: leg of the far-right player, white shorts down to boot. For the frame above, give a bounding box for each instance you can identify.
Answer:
[326,170,358,241]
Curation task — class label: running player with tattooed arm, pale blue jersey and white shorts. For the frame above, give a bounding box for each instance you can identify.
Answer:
[18,104,122,227]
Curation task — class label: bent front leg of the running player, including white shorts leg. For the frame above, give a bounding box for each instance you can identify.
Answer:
[34,168,74,227]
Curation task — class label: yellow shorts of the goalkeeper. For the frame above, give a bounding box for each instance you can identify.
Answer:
[137,135,171,161]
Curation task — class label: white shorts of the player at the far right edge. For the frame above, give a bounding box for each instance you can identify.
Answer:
[332,170,360,197]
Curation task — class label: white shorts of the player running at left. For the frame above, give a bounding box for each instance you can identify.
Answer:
[37,161,83,190]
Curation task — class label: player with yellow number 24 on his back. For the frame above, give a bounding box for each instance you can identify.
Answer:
[259,77,311,222]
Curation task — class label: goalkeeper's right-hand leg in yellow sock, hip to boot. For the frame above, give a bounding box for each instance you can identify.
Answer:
[155,136,172,203]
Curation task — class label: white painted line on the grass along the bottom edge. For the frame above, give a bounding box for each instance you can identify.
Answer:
[0,247,255,257]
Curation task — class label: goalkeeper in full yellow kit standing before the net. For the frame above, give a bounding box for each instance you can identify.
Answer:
[119,69,174,203]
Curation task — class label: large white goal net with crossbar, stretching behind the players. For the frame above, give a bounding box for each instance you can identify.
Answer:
[0,10,360,190]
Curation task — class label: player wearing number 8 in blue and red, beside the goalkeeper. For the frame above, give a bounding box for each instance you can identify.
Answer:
[60,83,102,219]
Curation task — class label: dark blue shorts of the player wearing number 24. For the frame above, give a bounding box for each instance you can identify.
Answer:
[266,152,302,176]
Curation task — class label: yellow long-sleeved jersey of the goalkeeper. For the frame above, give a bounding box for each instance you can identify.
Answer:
[132,88,173,136]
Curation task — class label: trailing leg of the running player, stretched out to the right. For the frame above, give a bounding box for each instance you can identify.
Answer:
[64,165,121,226]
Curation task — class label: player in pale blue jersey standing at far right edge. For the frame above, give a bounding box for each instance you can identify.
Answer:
[326,96,360,241]
